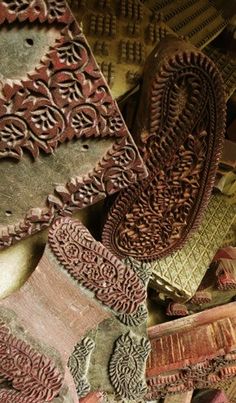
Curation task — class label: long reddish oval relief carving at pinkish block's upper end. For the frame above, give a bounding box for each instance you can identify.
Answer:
[49,217,146,314]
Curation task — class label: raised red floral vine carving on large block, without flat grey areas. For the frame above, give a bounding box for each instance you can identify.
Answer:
[0,0,146,248]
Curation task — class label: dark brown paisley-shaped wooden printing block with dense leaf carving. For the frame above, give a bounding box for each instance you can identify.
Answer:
[103,36,225,261]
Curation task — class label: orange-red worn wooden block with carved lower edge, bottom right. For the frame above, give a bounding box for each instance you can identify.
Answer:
[146,302,236,400]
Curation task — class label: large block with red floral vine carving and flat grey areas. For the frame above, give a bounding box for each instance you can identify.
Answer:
[0,0,146,248]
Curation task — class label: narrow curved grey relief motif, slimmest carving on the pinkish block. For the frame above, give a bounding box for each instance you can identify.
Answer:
[68,337,95,398]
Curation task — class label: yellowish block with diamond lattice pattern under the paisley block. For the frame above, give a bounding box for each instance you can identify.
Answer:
[148,195,236,301]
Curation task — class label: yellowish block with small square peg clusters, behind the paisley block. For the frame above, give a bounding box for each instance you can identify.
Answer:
[70,0,171,98]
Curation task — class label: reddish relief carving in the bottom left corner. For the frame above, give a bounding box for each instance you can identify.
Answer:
[0,319,63,403]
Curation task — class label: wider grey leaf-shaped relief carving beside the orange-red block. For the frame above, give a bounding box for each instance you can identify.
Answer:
[109,332,150,399]
